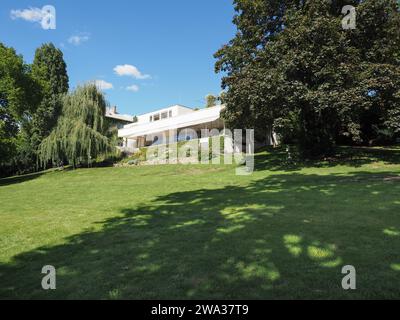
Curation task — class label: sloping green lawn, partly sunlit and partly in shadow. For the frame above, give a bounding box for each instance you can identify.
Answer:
[0,148,400,299]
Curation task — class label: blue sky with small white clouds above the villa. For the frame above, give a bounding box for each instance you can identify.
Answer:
[0,0,235,114]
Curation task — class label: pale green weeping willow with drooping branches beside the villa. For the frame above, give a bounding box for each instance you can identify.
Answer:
[39,84,112,168]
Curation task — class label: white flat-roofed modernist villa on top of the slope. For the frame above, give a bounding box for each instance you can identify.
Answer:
[118,105,224,152]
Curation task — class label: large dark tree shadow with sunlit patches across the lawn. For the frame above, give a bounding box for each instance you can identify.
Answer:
[0,173,400,299]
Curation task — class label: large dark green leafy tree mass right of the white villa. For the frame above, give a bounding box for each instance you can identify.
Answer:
[215,0,400,157]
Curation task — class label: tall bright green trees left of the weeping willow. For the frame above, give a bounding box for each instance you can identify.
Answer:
[0,44,68,174]
